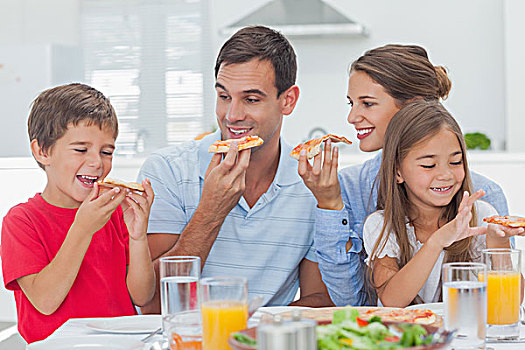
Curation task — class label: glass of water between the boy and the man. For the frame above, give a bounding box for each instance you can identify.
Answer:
[160,256,202,349]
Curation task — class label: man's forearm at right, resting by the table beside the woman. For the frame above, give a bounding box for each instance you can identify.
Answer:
[290,258,334,307]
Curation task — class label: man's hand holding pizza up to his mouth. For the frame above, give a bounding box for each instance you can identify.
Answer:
[199,142,251,220]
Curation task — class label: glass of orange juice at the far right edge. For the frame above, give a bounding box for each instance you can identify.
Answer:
[480,249,521,339]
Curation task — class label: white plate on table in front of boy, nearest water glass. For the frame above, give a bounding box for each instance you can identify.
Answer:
[86,315,162,334]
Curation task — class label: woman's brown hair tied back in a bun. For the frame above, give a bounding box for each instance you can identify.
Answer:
[350,44,452,107]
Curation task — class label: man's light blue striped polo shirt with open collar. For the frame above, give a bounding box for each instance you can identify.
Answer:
[139,132,317,305]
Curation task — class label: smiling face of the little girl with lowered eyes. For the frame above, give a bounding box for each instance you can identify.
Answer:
[396,128,465,209]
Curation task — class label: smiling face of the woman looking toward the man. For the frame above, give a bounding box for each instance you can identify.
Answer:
[347,71,400,152]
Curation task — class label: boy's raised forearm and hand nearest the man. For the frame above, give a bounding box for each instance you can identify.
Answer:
[122,179,155,306]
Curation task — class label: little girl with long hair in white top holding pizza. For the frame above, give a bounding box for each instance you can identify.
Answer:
[363,100,524,307]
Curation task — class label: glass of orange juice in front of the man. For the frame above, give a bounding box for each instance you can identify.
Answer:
[200,277,248,350]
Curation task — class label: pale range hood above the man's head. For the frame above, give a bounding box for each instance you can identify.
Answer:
[220,0,366,37]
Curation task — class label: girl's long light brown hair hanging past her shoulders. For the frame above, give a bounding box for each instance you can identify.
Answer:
[370,100,477,302]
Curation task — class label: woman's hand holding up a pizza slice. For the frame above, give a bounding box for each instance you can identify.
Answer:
[297,140,344,210]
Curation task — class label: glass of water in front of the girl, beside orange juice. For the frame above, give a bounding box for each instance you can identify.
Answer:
[442,262,487,349]
